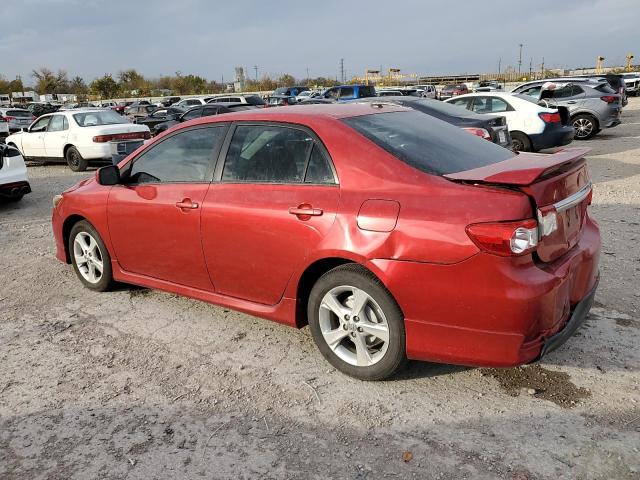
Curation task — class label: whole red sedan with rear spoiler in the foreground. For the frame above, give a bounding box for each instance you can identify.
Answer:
[53,104,600,380]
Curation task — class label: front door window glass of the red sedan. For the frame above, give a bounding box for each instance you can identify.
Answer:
[127,125,225,184]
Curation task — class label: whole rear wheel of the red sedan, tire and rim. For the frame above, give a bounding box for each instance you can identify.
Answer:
[307,264,407,381]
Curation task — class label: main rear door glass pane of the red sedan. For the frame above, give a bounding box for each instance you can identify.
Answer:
[222,125,314,183]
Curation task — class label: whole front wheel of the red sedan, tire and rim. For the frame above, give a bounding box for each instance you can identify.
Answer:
[69,220,115,292]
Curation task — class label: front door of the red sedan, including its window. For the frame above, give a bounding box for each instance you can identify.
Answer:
[107,124,227,291]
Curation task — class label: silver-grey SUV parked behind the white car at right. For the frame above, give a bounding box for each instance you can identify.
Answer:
[514,80,622,140]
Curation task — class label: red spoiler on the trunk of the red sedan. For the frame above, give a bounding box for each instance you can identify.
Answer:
[444,148,591,185]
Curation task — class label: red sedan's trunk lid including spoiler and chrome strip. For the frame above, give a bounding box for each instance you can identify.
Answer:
[445,148,591,262]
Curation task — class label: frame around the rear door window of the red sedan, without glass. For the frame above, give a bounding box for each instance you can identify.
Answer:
[213,120,340,187]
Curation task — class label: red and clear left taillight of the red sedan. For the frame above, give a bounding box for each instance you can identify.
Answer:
[466,219,538,257]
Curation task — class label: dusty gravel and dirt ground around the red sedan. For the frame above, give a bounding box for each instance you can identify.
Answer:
[0,98,640,480]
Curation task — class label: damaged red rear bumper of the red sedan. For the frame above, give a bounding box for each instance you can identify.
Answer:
[371,219,600,367]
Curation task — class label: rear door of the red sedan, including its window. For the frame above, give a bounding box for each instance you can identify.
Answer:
[202,123,340,305]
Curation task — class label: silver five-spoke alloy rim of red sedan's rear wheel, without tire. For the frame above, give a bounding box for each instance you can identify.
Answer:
[319,285,389,367]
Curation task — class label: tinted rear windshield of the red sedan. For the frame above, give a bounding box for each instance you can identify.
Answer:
[342,112,513,175]
